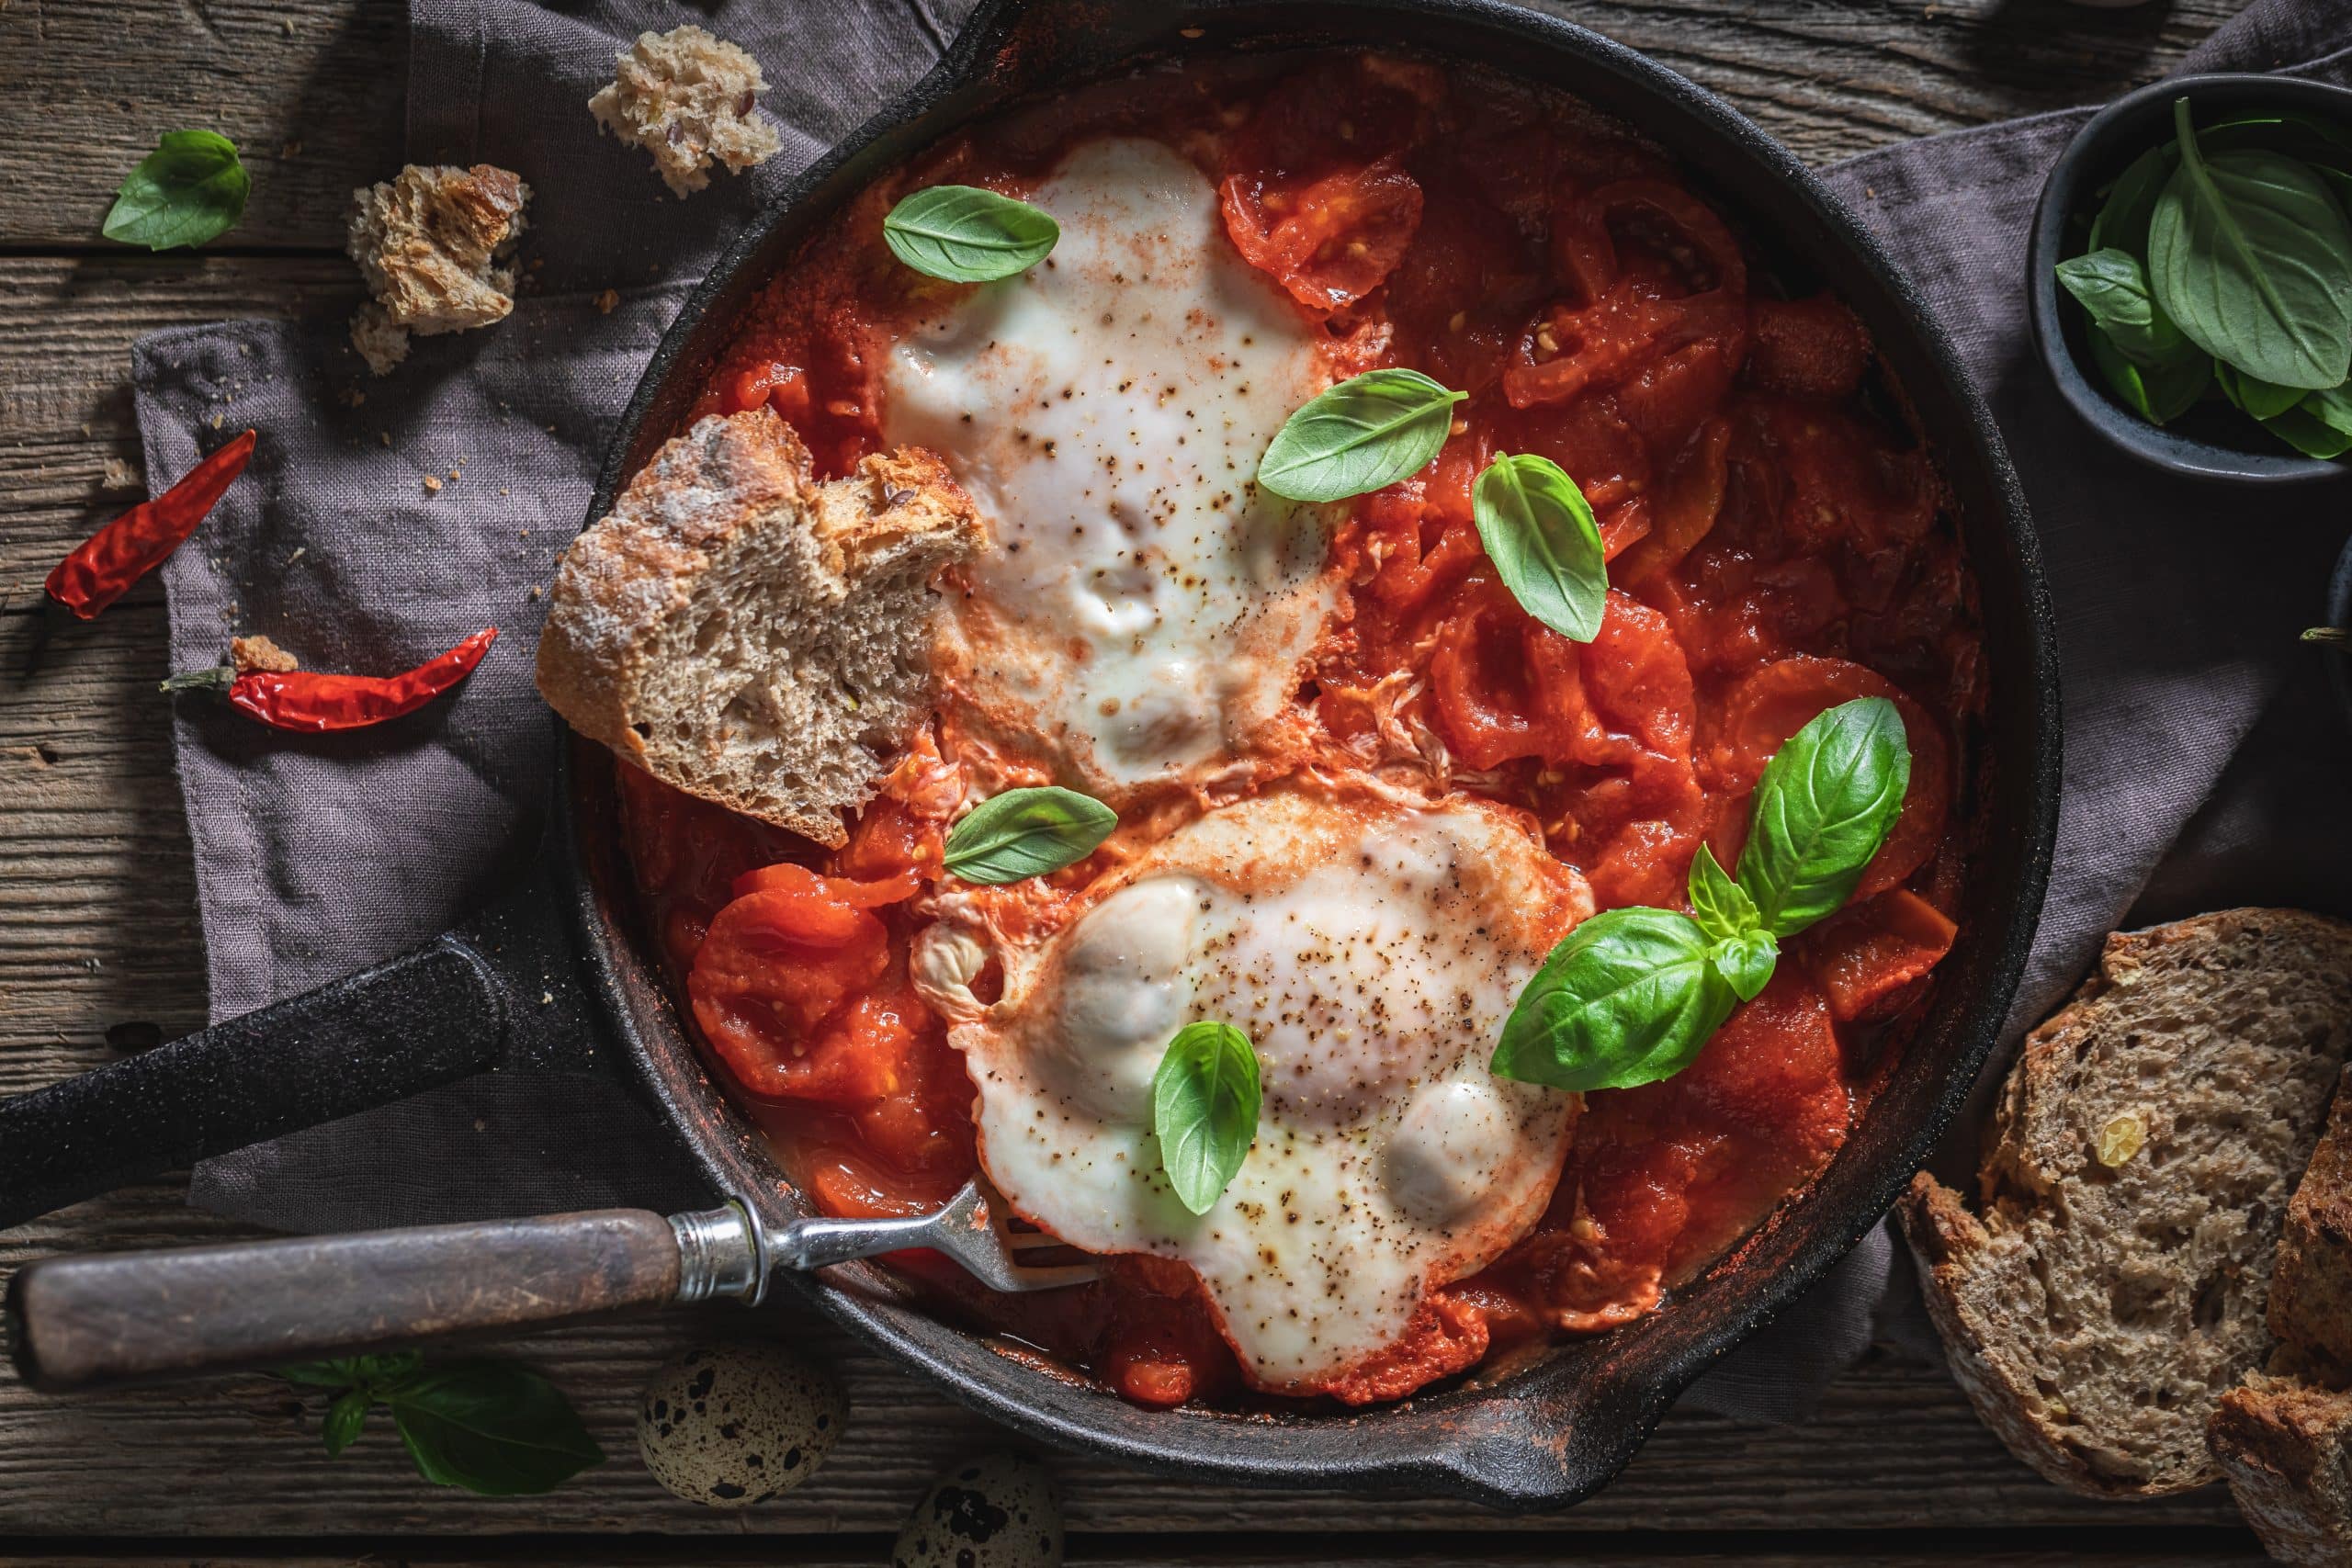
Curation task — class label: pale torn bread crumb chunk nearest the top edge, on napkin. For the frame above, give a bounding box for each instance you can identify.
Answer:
[588,24,783,197]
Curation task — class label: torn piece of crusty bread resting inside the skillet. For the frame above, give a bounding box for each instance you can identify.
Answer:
[538,407,981,846]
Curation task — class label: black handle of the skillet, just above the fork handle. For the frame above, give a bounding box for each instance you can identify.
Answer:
[0,872,612,1229]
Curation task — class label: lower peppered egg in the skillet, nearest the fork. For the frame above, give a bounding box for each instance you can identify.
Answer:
[915,787,1592,1394]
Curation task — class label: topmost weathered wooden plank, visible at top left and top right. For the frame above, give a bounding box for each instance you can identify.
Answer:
[0,0,2239,249]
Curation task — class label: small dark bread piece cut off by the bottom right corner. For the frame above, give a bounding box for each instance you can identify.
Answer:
[2206,1373,2352,1568]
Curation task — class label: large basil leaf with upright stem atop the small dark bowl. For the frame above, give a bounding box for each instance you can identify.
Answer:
[2147,98,2352,388]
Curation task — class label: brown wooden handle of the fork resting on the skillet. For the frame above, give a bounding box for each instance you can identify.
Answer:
[7,1208,680,1394]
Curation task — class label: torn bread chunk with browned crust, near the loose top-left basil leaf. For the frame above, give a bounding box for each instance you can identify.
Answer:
[344,163,532,376]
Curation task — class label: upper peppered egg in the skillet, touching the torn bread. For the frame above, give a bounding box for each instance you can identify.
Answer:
[885,139,1334,799]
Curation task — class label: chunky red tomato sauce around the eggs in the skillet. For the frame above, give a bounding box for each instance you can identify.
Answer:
[621,54,1983,1405]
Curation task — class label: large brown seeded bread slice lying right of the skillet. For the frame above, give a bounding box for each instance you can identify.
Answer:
[1900,909,2352,1497]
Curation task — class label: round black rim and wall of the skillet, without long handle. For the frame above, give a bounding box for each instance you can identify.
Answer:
[550,0,2061,1509]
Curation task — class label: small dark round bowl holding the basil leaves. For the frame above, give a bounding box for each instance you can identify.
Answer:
[2025,75,2352,484]
